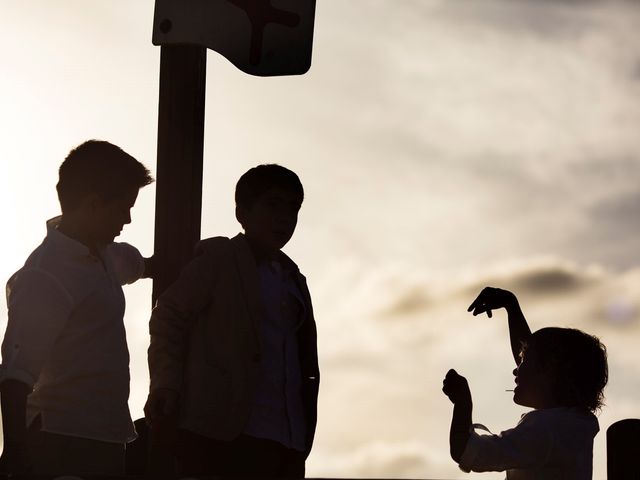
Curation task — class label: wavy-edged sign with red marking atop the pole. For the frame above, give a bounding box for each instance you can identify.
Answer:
[153,0,315,76]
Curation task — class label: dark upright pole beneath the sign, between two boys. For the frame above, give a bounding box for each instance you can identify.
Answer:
[152,45,207,304]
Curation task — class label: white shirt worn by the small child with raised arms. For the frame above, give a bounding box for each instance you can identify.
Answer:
[460,407,600,480]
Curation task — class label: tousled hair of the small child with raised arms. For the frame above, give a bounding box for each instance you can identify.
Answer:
[522,327,609,413]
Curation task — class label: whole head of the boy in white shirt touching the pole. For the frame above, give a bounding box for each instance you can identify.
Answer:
[56,140,153,249]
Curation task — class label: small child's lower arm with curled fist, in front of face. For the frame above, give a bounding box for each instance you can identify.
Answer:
[442,369,473,463]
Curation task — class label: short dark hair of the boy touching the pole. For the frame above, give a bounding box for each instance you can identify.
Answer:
[56,140,153,213]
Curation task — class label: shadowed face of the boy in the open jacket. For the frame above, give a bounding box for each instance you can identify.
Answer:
[236,187,302,255]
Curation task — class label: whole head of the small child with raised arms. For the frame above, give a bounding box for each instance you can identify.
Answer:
[514,327,609,412]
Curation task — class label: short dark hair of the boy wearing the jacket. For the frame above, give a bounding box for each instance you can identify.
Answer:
[235,163,304,208]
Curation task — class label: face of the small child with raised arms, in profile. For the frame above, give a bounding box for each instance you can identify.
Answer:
[513,347,555,408]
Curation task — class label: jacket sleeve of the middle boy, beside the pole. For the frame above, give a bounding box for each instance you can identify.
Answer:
[148,242,220,391]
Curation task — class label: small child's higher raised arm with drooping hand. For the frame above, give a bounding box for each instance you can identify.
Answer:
[467,287,531,365]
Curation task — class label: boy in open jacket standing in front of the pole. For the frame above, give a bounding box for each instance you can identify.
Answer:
[145,164,319,478]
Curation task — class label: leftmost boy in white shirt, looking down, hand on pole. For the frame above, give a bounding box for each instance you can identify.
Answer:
[0,140,153,475]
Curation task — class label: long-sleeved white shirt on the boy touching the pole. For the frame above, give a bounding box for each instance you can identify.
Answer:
[0,217,144,443]
